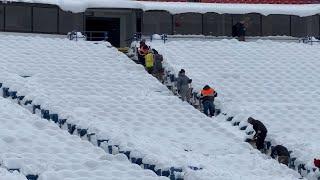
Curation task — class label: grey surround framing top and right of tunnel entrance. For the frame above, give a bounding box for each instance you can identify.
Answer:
[86,9,136,46]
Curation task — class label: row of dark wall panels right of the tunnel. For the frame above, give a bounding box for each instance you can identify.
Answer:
[142,11,320,37]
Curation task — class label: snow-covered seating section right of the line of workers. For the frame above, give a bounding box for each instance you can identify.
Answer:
[151,39,320,171]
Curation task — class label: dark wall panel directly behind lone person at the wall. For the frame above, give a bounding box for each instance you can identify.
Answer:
[232,13,262,36]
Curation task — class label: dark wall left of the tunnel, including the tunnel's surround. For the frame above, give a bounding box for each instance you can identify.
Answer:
[0,2,136,46]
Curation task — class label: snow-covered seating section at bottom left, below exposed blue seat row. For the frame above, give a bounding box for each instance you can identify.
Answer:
[0,97,167,180]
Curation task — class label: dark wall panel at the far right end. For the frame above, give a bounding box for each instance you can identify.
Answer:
[291,16,319,37]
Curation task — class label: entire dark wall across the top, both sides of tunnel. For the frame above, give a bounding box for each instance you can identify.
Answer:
[0,2,320,46]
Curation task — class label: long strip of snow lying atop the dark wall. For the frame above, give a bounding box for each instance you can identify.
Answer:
[2,0,320,17]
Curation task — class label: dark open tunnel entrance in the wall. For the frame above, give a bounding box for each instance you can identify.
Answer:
[86,17,120,47]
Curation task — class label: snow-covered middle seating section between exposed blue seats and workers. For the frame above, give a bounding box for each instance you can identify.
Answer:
[0,36,299,180]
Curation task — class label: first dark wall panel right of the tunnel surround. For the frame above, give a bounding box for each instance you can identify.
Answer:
[142,11,173,35]
